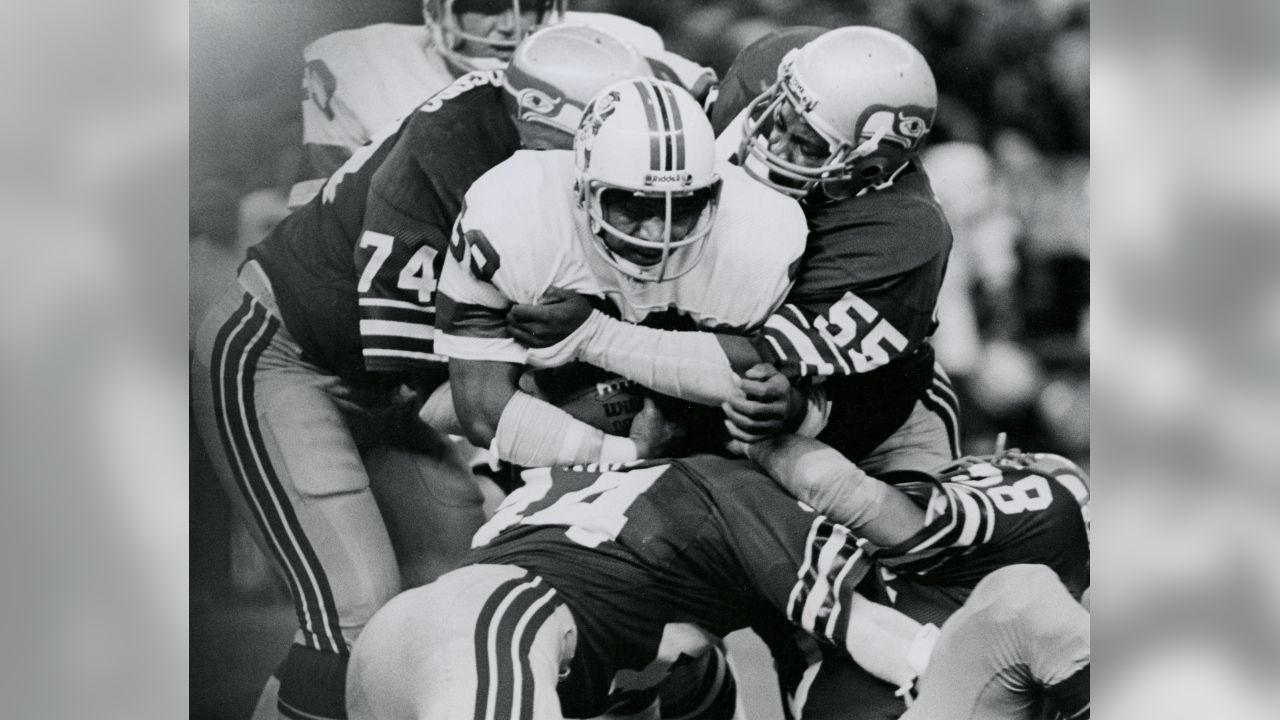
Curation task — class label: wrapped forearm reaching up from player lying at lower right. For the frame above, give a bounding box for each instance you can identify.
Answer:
[746,434,925,547]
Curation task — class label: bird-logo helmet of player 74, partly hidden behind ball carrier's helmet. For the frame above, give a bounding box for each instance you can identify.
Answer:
[503,24,653,149]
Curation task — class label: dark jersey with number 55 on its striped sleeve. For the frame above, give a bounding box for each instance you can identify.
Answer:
[756,160,952,461]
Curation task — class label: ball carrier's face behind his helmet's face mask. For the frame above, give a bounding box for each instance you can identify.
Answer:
[602,191,707,266]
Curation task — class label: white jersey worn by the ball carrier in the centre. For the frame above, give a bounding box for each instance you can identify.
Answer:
[435,150,806,363]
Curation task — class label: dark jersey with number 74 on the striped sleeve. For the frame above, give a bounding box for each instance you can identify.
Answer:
[248,72,520,382]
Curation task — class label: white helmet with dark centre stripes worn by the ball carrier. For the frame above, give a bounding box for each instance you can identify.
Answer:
[573,78,721,282]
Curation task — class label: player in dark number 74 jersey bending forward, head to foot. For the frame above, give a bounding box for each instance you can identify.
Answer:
[191,26,650,717]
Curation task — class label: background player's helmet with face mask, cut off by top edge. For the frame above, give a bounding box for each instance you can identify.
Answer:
[422,0,568,76]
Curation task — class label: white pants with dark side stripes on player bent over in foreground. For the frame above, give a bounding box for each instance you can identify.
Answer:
[347,565,577,720]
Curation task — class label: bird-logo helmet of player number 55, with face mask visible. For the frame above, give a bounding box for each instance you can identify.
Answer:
[739,26,938,197]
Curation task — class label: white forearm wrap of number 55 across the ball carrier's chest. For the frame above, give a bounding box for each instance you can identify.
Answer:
[577,310,736,405]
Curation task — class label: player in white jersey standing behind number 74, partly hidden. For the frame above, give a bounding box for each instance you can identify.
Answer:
[289,0,717,209]
